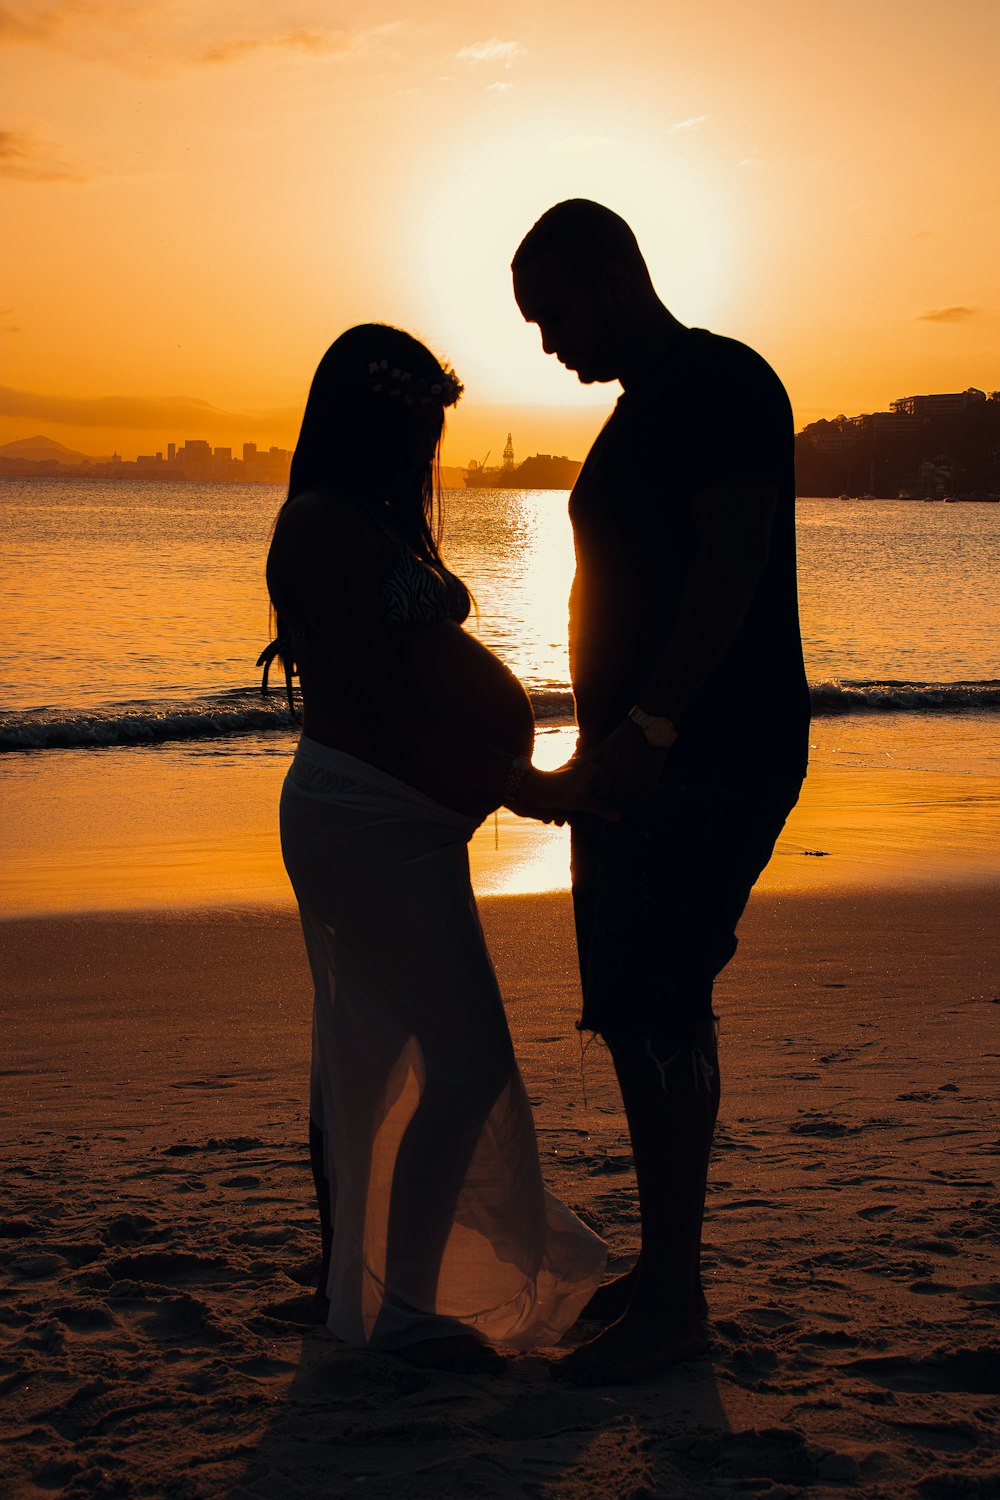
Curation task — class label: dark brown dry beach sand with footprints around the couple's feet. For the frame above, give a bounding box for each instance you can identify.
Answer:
[0,884,1000,1500]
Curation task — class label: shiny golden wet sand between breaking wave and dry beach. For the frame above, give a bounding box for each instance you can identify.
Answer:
[0,744,1000,923]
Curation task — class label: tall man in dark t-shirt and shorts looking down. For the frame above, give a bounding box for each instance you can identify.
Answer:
[511,200,808,1385]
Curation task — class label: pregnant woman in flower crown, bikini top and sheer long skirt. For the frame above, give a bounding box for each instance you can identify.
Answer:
[261,324,604,1371]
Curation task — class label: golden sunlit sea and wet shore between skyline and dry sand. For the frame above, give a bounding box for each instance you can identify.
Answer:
[0,479,1000,911]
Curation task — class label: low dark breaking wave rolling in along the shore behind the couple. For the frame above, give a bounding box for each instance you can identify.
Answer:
[0,678,1000,752]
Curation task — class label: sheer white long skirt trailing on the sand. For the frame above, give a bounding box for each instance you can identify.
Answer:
[280,740,604,1349]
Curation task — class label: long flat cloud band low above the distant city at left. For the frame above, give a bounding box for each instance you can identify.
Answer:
[0,386,301,435]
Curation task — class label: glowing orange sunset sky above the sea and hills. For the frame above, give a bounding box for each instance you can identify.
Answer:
[0,0,1000,464]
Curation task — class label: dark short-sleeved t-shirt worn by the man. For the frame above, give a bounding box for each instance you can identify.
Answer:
[570,329,810,780]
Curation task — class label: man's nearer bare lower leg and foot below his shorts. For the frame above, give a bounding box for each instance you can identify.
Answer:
[553,1022,720,1385]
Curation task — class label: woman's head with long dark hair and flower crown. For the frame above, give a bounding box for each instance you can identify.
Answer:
[288,323,462,519]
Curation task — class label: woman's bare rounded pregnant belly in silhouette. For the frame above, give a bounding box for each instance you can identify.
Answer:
[400,621,535,756]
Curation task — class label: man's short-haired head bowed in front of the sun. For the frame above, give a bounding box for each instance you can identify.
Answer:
[511,198,661,384]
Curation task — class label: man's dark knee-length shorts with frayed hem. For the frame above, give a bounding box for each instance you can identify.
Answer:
[573,776,802,1046]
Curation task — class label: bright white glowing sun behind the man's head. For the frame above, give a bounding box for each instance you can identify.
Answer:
[411,102,744,405]
